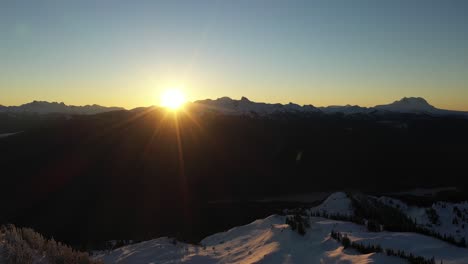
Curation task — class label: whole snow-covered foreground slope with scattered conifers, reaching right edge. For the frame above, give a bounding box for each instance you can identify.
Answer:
[96,193,468,263]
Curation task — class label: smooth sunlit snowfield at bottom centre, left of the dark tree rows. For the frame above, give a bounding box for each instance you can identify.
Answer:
[98,215,405,264]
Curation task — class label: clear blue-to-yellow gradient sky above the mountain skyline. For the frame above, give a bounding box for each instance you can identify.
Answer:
[0,0,468,110]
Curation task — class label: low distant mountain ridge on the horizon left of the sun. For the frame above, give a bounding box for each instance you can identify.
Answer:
[0,101,125,115]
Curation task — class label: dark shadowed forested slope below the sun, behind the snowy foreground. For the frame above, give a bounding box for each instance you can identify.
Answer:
[0,108,468,248]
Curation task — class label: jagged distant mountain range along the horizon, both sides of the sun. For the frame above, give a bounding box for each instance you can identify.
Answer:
[0,97,468,116]
